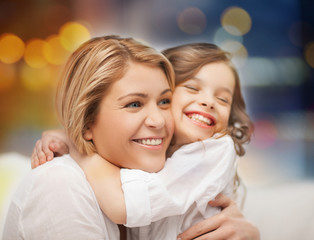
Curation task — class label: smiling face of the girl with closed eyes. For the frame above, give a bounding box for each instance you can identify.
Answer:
[172,62,235,146]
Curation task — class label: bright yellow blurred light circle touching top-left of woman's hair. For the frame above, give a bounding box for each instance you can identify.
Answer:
[59,22,90,52]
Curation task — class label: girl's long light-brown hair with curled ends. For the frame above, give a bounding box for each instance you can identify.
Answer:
[163,43,253,156]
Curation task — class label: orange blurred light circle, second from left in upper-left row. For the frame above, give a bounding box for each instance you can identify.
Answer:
[24,39,48,68]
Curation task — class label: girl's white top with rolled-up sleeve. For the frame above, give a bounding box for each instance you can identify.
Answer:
[121,135,236,240]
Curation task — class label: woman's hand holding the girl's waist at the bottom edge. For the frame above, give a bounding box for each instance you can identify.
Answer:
[178,194,260,240]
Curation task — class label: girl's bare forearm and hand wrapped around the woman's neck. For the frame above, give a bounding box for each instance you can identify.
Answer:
[31,130,126,224]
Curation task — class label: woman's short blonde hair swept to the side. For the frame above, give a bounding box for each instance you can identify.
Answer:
[56,36,174,154]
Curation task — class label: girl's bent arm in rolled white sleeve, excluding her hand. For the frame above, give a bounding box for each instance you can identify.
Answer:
[33,132,235,227]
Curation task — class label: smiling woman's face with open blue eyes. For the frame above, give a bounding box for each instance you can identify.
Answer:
[84,63,174,172]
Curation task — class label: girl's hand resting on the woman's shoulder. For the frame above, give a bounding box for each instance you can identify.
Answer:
[31,130,69,168]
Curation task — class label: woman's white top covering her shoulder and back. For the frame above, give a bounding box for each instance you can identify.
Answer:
[2,155,119,240]
